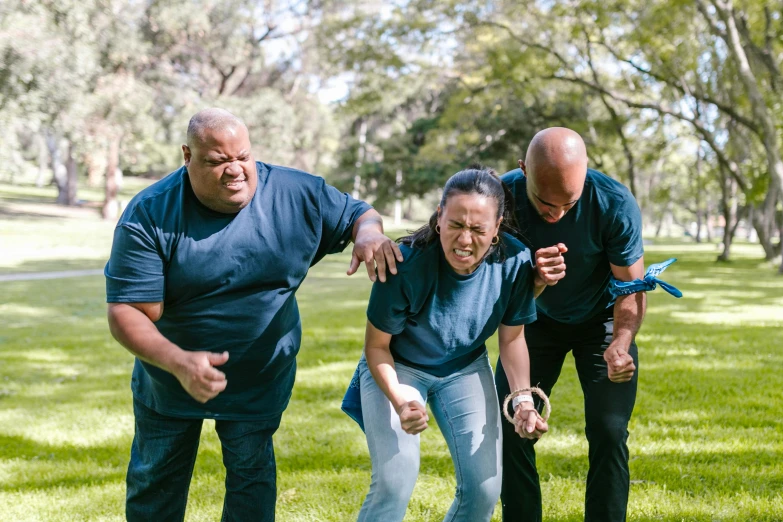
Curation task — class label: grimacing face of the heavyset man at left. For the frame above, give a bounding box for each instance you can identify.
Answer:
[182,125,258,214]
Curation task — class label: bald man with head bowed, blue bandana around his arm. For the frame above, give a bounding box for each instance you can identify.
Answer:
[495,127,646,522]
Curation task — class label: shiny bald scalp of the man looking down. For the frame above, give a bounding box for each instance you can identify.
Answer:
[525,127,587,191]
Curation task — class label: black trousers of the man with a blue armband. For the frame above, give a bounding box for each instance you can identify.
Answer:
[495,309,639,522]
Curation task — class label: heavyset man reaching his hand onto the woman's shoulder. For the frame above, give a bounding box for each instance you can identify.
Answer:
[105,109,402,522]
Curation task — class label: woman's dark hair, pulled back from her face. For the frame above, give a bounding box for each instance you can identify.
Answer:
[397,165,519,261]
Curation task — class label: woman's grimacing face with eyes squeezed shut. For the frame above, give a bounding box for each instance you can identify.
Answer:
[438,193,503,274]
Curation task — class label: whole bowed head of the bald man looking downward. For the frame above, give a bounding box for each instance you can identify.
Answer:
[520,127,587,223]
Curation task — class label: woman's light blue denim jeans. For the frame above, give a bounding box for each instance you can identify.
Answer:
[359,354,503,522]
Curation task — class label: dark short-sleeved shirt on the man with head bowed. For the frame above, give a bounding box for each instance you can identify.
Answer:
[501,169,644,324]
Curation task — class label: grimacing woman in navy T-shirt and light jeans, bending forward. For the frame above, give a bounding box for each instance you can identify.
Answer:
[349,169,547,522]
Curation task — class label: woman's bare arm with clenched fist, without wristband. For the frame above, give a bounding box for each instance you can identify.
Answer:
[364,321,429,435]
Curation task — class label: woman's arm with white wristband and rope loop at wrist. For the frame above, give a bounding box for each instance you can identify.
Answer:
[498,324,549,439]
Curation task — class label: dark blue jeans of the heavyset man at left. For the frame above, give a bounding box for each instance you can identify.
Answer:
[125,400,280,522]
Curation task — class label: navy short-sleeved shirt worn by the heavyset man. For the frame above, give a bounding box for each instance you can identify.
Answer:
[105,162,370,420]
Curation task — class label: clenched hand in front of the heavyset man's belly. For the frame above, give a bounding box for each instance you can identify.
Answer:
[172,351,228,404]
